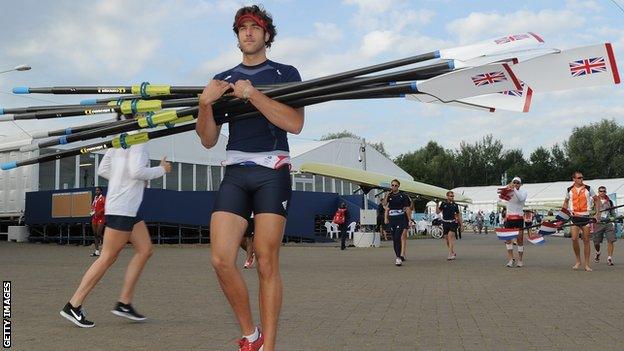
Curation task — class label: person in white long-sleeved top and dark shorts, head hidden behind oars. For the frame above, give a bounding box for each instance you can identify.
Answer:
[60,144,171,328]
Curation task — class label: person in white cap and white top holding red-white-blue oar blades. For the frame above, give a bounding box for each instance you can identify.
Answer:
[505,176,527,268]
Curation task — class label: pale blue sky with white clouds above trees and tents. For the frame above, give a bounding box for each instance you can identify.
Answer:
[0,0,624,157]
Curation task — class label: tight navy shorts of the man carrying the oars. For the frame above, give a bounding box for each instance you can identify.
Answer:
[213,165,292,218]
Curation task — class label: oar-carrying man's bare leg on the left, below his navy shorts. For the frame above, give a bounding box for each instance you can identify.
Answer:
[210,211,255,335]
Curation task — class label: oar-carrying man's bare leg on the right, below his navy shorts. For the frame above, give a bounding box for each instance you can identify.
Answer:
[254,213,286,351]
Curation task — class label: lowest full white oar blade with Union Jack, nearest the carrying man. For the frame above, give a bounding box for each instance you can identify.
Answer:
[416,63,522,102]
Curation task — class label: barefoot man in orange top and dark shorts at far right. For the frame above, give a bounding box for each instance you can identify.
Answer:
[562,171,600,272]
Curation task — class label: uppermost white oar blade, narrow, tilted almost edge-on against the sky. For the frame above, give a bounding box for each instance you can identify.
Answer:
[439,32,544,61]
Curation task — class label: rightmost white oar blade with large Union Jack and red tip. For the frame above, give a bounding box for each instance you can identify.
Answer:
[511,43,620,92]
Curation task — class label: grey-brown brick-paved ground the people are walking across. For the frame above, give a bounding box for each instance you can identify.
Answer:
[0,234,624,351]
